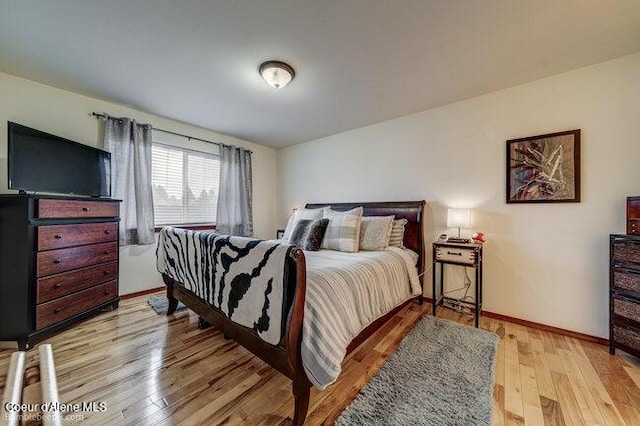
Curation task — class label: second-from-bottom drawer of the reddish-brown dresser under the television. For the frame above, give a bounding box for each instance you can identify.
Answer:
[36,262,118,303]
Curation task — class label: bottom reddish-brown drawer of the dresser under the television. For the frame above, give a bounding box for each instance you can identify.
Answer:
[36,281,118,330]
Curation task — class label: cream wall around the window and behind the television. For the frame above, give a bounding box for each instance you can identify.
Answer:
[0,73,277,294]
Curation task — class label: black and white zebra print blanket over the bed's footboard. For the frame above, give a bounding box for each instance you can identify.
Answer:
[156,227,293,345]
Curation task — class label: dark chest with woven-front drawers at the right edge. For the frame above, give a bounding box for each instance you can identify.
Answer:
[609,235,640,356]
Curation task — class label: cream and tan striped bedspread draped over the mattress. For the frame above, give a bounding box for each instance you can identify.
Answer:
[302,247,421,389]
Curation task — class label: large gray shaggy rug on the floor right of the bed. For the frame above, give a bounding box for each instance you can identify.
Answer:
[336,316,499,426]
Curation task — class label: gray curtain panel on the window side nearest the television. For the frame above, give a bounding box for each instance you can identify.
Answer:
[104,116,155,246]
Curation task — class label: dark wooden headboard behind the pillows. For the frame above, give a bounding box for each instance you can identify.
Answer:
[305,200,425,282]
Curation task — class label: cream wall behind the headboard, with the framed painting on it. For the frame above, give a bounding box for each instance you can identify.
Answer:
[278,54,640,337]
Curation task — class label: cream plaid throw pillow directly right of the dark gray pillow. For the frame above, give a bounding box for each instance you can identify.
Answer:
[322,207,362,253]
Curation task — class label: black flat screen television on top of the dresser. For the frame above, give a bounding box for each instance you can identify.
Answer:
[8,122,111,197]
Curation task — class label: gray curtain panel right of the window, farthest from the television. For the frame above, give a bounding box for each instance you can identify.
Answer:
[216,145,253,237]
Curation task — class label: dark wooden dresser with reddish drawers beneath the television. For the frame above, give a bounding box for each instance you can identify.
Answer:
[0,195,120,350]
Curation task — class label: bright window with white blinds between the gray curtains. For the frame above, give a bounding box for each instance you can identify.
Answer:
[151,143,220,226]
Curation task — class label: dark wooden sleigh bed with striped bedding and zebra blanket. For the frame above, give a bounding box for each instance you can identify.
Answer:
[158,201,425,425]
